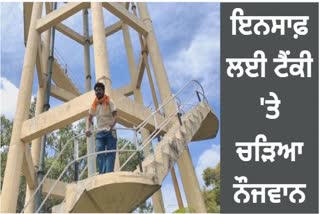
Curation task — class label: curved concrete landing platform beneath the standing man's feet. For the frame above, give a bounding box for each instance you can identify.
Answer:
[52,172,161,213]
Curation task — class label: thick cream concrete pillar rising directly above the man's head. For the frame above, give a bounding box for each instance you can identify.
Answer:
[91,2,112,94]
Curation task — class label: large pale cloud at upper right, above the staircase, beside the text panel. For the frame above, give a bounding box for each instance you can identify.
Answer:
[166,9,220,102]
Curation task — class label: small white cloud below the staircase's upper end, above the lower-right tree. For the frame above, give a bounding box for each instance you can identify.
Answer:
[195,144,220,187]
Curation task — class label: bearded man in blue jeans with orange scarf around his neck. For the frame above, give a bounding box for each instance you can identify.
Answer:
[86,82,117,174]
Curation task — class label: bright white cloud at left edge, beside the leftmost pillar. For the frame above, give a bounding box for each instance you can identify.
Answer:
[0,77,19,119]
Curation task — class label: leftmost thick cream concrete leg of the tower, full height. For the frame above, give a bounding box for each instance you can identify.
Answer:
[1,2,42,213]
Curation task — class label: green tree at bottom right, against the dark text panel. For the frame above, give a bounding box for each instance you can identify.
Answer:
[202,163,220,213]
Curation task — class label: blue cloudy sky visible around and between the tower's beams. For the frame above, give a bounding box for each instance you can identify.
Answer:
[0,2,220,212]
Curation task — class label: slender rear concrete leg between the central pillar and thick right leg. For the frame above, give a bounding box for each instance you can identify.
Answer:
[122,24,166,213]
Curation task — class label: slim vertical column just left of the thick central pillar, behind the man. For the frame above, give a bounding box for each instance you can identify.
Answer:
[82,9,96,177]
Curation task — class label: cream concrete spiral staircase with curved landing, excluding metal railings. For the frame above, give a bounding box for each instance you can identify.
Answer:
[52,102,218,213]
